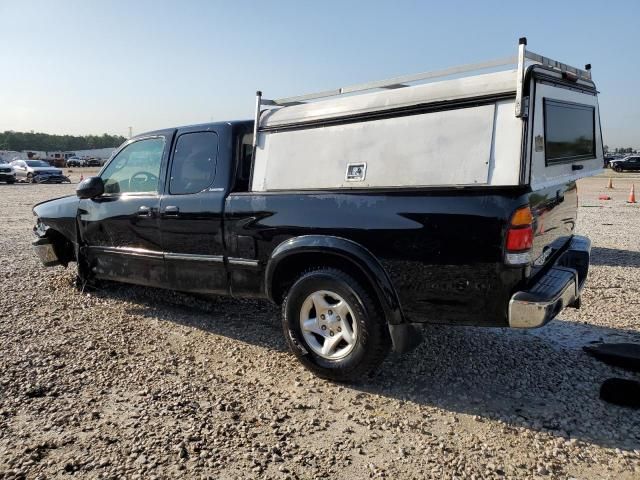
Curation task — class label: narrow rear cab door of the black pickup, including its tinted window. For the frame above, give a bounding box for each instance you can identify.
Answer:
[160,127,228,293]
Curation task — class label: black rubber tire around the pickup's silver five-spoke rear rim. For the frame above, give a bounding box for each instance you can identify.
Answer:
[282,268,391,382]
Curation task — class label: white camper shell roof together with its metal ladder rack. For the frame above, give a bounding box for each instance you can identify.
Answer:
[254,37,593,132]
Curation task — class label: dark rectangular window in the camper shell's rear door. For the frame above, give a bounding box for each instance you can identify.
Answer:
[544,99,596,164]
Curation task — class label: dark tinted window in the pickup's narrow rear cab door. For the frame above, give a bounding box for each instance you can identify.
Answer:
[169,132,218,195]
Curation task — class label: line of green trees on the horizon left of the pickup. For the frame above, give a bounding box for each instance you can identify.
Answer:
[0,131,126,152]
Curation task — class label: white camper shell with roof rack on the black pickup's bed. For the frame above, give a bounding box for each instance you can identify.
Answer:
[251,39,604,191]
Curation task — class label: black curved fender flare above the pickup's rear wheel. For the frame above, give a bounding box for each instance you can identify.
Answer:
[265,235,404,324]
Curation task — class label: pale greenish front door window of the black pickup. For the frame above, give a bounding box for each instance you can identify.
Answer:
[100,137,164,194]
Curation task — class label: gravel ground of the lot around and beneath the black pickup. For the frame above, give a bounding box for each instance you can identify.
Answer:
[0,172,640,479]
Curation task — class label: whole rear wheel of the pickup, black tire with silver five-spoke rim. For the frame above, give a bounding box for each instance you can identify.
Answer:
[282,268,391,382]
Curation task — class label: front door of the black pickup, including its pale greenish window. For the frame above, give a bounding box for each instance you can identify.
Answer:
[78,131,173,287]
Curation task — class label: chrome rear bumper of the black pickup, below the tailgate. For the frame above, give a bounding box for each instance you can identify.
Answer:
[509,235,591,328]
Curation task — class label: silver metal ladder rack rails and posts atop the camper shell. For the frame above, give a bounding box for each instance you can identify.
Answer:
[254,37,591,125]
